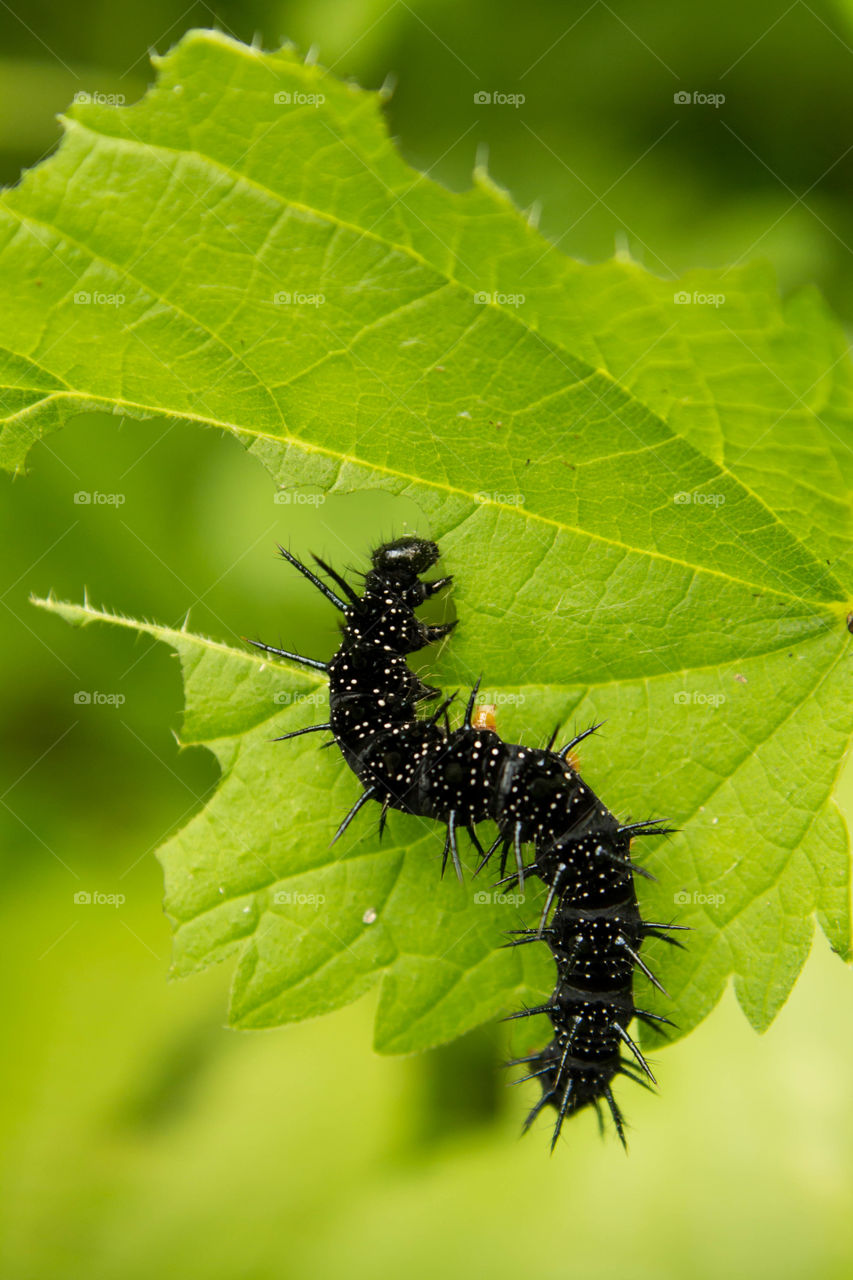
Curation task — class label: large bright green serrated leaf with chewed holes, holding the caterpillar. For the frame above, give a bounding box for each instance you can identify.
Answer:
[14,32,853,1050]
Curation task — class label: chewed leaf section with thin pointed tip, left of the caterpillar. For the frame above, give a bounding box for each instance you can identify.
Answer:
[29,600,553,1052]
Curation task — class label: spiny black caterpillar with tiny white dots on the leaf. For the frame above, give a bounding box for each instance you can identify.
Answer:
[245,538,679,1148]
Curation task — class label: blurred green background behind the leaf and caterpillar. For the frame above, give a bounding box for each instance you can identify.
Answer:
[0,0,853,1280]
